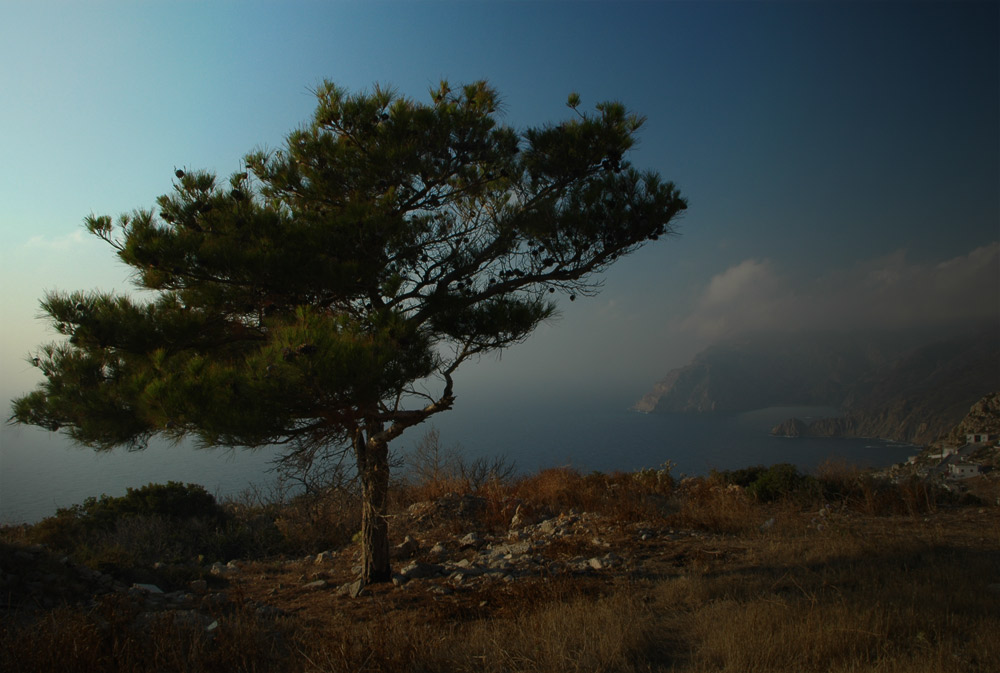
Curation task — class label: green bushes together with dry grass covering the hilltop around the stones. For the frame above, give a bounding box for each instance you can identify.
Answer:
[0,456,1000,673]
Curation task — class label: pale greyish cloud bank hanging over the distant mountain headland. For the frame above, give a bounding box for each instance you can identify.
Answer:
[679,242,1000,342]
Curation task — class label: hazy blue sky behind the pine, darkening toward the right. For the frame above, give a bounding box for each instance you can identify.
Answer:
[0,0,1000,415]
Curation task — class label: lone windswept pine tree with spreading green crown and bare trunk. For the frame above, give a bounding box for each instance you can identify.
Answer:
[12,82,686,583]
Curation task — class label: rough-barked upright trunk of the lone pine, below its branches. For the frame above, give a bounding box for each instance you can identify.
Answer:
[354,430,392,585]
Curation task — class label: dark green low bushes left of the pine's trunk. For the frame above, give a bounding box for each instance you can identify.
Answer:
[23,482,372,581]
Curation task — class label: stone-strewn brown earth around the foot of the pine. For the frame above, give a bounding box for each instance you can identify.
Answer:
[0,495,680,631]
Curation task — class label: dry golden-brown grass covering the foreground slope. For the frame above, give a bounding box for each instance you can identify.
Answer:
[0,462,1000,673]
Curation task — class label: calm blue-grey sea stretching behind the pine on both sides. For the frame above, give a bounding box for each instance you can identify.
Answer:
[0,388,917,523]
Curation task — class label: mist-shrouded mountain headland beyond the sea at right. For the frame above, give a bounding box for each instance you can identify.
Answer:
[635,329,1000,444]
